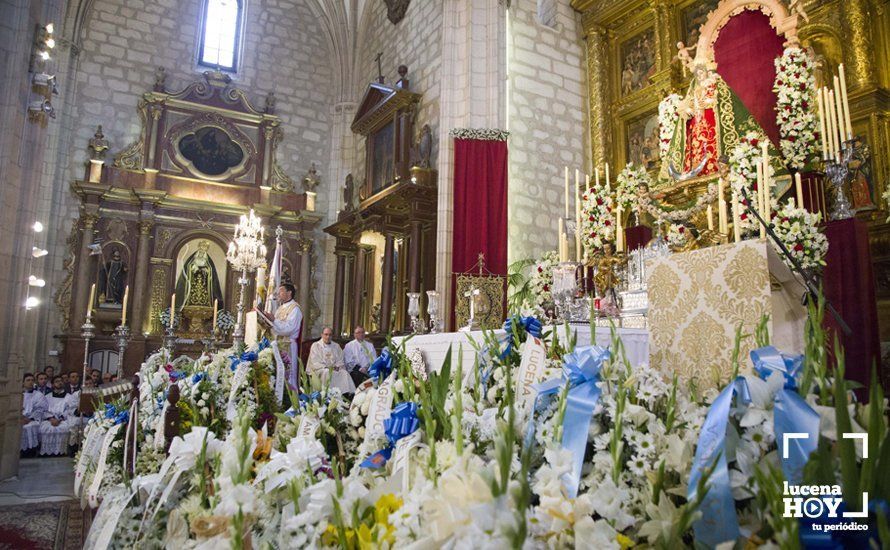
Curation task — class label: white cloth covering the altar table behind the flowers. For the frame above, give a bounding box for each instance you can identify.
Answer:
[392,324,649,372]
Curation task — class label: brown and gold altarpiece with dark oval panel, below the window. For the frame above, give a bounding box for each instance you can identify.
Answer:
[57,72,321,373]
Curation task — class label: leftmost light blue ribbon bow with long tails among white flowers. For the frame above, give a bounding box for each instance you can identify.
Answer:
[536,346,611,498]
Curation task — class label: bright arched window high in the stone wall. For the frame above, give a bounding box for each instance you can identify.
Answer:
[198,0,244,72]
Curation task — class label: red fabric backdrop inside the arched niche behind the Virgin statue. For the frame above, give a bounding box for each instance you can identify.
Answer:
[714,10,785,144]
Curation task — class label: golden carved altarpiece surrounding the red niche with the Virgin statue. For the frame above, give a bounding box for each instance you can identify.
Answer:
[572,0,890,340]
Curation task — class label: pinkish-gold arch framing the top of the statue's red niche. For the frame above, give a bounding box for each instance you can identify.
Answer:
[695,0,798,62]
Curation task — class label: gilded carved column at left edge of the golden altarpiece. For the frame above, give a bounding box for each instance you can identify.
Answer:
[584,24,610,168]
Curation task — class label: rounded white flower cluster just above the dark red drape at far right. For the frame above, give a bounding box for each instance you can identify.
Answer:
[773,199,828,269]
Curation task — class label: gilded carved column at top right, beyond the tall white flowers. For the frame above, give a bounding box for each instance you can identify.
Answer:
[839,0,877,89]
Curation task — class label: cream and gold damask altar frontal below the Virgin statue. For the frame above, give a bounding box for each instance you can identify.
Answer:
[648,240,804,386]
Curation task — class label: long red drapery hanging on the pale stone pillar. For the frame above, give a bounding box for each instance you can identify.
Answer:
[451,139,507,325]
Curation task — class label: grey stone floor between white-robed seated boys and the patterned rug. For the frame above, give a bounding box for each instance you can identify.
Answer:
[0,457,74,506]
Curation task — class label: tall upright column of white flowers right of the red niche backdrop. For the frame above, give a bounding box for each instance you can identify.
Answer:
[773,46,819,170]
